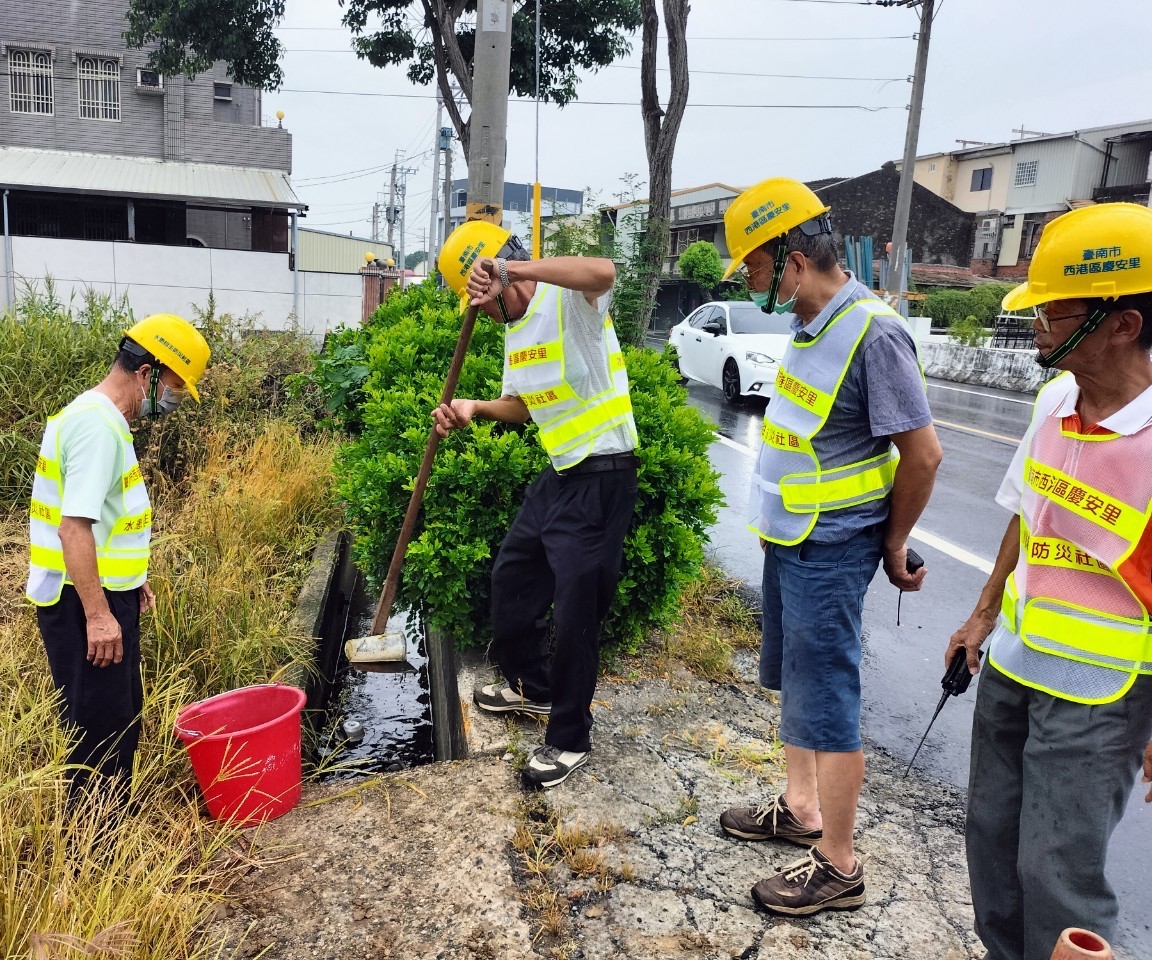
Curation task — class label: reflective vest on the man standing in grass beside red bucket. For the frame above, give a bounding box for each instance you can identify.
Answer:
[25,396,152,606]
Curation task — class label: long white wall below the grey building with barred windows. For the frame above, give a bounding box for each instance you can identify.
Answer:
[0,236,363,338]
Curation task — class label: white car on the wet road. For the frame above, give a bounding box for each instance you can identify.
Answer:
[668,300,793,403]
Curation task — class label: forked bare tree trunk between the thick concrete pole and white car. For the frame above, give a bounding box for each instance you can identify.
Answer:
[639,0,690,341]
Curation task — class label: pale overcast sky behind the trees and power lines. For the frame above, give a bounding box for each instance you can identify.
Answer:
[264,0,1152,250]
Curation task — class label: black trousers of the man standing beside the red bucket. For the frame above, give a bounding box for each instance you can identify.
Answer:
[36,584,144,796]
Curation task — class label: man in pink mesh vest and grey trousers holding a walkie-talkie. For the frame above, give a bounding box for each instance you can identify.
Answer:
[945,203,1152,960]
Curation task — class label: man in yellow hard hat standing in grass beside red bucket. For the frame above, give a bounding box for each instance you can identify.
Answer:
[26,313,210,798]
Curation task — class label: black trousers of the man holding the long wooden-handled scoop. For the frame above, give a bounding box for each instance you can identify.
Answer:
[488,467,637,750]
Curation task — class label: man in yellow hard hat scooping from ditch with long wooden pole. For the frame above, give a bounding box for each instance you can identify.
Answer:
[434,220,639,787]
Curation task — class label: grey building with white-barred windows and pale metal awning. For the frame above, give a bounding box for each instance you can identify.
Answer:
[0,0,303,254]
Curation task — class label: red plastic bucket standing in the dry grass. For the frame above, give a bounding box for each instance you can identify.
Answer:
[176,683,305,826]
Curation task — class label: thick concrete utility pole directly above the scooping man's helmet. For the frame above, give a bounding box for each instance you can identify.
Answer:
[468,0,513,225]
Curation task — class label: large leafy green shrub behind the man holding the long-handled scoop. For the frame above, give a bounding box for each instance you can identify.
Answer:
[325,276,721,651]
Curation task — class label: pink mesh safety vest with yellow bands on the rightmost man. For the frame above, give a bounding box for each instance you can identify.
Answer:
[988,375,1152,703]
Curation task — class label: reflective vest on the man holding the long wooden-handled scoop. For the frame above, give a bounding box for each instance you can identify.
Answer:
[505,284,636,470]
